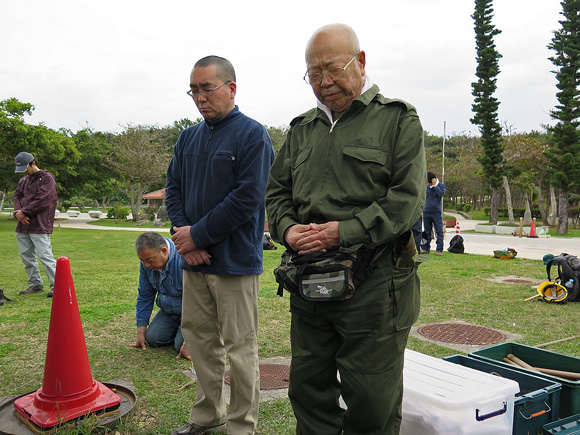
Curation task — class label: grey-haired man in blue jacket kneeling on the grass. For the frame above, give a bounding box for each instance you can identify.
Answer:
[131,231,191,359]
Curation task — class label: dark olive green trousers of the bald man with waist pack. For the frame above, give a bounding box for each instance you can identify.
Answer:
[288,255,420,435]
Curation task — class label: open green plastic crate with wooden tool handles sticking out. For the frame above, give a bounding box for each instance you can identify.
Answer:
[469,342,580,418]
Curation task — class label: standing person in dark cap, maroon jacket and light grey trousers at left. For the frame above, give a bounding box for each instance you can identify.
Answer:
[14,152,56,297]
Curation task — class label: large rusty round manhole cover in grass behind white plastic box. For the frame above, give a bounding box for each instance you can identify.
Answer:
[417,323,506,345]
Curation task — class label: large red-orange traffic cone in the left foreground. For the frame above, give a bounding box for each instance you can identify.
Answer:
[14,257,121,431]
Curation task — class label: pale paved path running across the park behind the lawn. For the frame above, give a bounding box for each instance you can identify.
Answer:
[54,212,580,260]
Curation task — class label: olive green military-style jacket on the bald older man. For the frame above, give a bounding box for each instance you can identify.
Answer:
[266,85,427,250]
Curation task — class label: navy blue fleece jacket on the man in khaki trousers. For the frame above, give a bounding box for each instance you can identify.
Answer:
[165,106,274,275]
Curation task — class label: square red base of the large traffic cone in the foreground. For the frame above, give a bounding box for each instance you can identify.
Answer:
[14,381,121,432]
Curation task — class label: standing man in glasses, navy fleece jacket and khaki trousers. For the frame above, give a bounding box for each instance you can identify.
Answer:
[165,56,274,435]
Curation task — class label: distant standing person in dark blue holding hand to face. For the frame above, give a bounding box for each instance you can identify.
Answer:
[421,171,445,255]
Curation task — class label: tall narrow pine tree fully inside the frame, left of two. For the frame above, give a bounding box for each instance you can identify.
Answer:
[471,0,504,224]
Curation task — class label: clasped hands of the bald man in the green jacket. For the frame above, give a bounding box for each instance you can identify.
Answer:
[284,221,339,255]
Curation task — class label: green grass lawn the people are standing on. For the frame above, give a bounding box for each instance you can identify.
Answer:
[0,216,580,435]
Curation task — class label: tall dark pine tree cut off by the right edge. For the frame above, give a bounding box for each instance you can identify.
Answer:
[545,0,580,234]
